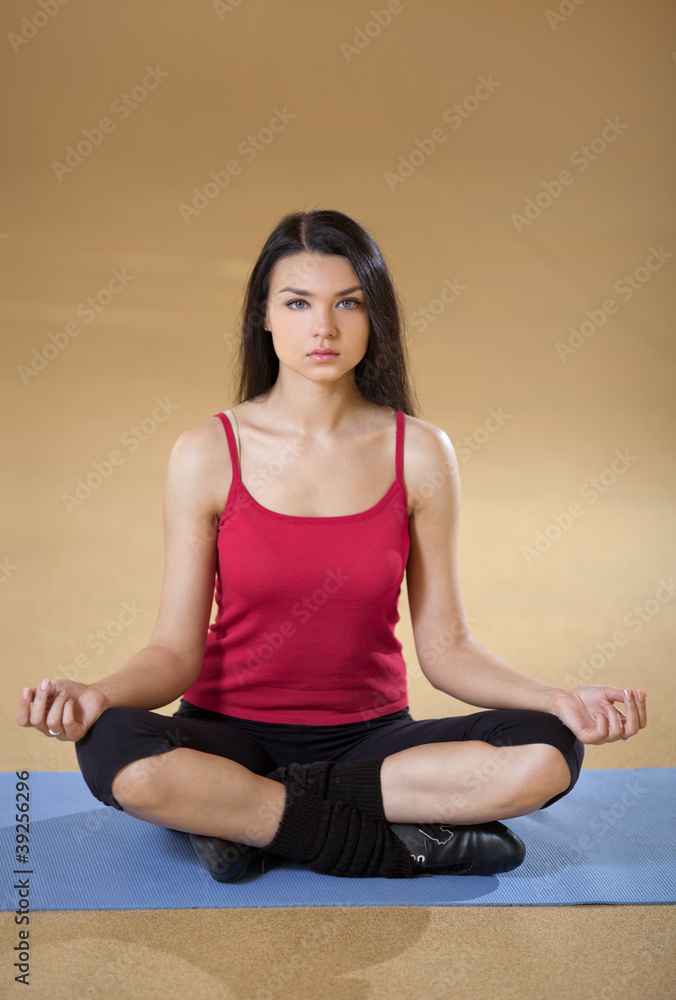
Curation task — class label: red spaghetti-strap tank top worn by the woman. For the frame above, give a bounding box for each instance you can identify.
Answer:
[184,410,410,726]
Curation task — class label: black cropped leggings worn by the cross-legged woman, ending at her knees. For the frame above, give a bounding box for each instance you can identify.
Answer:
[75,700,584,809]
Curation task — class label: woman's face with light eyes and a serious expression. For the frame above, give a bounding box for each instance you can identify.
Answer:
[263,253,370,382]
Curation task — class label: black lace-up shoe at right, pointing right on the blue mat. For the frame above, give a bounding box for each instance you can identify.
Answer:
[390,820,526,876]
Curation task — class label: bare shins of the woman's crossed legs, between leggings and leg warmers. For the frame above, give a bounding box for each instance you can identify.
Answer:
[111,740,571,847]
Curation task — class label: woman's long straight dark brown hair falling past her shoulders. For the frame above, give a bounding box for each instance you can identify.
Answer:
[233,209,418,417]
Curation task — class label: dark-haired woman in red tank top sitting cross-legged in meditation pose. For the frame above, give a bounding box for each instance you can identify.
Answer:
[17,210,646,881]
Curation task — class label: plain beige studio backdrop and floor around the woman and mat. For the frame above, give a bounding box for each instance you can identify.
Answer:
[0,0,676,1000]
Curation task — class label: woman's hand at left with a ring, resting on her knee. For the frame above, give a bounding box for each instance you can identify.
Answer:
[16,677,108,742]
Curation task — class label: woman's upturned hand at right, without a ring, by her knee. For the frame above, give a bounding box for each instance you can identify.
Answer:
[552,684,647,744]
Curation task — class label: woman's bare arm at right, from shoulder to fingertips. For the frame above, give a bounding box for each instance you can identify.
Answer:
[406,421,646,743]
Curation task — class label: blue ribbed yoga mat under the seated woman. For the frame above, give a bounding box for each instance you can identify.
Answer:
[0,768,676,910]
